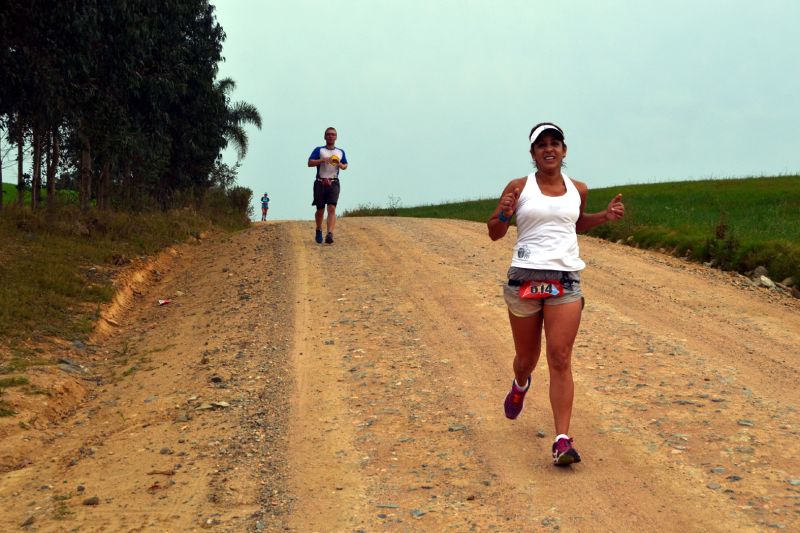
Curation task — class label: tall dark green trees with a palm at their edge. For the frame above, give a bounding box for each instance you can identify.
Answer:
[0,0,261,210]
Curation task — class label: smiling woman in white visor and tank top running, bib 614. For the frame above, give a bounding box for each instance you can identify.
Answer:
[487,123,625,465]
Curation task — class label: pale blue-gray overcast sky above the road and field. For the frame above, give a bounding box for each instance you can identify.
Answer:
[214,0,800,219]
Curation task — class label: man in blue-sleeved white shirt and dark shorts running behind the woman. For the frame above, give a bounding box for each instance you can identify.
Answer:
[308,128,347,244]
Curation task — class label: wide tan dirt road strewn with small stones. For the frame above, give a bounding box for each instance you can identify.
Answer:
[0,218,800,532]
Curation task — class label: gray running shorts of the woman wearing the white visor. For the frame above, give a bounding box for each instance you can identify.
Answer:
[503,267,583,318]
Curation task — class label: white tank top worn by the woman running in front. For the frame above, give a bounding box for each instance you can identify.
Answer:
[511,172,586,272]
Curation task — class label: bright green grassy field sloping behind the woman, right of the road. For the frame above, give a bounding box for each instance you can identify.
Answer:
[344,176,800,281]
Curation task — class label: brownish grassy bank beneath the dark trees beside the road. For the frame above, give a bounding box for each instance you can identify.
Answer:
[0,184,249,362]
